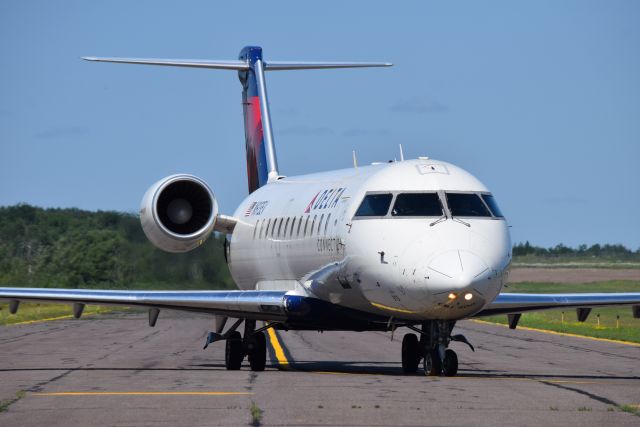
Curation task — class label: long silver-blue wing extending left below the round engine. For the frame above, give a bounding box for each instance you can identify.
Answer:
[0,288,290,320]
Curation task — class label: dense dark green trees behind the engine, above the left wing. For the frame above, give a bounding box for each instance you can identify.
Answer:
[0,204,235,289]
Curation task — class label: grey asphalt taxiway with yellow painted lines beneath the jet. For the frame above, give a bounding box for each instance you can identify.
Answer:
[0,312,640,426]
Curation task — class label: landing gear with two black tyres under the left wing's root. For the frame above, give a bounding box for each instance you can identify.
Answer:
[204,319,267,371]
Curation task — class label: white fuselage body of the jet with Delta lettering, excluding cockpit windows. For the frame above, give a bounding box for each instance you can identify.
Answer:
[228,159,511,319]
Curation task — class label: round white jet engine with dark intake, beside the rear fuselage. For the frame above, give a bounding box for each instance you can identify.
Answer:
[140,174,218,252]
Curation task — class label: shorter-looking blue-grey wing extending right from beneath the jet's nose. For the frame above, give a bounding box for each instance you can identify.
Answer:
[474,292,640,317]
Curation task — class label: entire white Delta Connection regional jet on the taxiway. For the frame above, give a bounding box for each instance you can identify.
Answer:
[0,47,640,376]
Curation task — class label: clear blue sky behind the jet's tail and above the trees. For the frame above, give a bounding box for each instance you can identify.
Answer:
[0,0,640,249]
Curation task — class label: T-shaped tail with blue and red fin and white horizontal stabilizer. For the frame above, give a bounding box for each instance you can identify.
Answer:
[83,46,392,193]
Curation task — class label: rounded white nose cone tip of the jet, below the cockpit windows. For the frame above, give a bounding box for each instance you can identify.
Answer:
[427,250,489,294]
